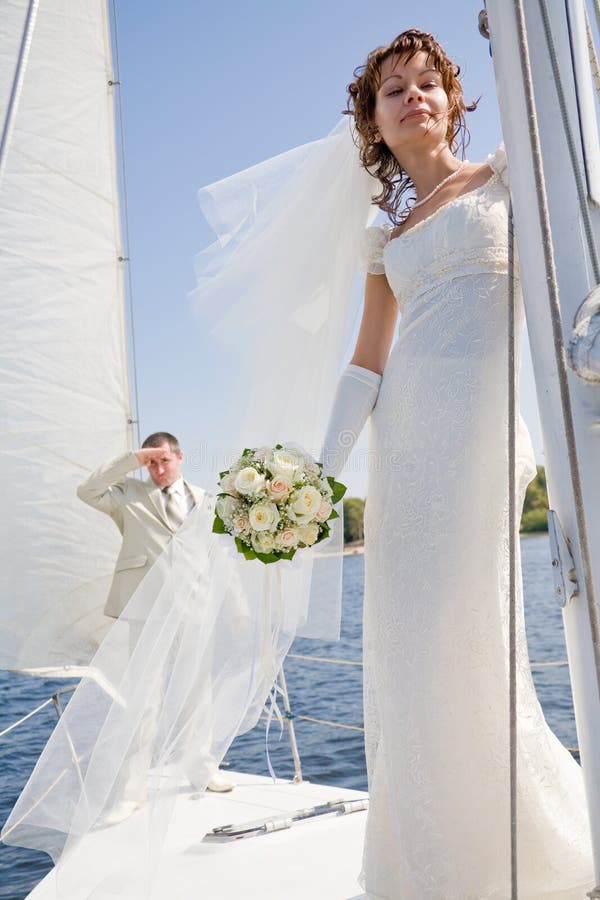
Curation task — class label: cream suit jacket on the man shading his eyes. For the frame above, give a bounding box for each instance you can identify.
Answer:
[77,452,205,618]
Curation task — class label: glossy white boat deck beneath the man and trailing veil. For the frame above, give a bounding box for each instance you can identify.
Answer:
[29,773,367,900]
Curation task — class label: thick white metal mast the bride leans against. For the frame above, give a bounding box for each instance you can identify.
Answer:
[487,0,600,884]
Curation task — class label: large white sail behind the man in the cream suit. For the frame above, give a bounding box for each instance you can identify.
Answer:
[0,0,131,674]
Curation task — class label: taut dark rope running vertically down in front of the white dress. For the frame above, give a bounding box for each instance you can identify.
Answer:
[508,204,518,900]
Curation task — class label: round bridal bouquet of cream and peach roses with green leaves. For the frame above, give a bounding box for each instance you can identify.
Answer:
[213,444,346,563]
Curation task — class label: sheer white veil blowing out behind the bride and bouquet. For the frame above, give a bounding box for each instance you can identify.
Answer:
[3,119,374,900]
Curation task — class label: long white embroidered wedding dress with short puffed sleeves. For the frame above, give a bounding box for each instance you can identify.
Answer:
[362,144,593,900]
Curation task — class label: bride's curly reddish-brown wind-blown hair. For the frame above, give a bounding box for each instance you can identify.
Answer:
[344,28,477,225]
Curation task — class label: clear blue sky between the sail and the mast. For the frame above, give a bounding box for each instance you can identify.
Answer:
[109,0,542,496]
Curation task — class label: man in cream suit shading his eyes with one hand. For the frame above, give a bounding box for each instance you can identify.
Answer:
[77,431,234,800]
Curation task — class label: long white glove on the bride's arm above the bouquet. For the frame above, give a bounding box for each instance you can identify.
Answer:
[321,365,381,478]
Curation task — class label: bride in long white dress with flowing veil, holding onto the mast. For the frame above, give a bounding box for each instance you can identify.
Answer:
[3,24,592,900]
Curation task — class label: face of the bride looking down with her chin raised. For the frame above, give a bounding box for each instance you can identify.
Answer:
[375,52,448,156]
